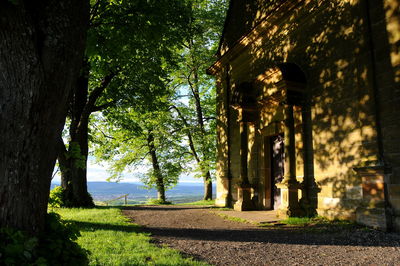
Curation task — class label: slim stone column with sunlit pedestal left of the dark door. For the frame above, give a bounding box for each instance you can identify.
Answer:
[233,119,253,211]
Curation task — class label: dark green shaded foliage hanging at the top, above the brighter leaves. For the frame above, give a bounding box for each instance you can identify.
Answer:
[87,0,189,109]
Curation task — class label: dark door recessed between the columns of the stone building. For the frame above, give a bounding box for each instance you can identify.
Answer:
[271,134,285,210]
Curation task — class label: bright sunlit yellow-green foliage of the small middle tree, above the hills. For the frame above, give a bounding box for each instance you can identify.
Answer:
[94,101,183,194]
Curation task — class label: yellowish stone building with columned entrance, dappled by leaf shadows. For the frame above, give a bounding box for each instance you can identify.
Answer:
[208,0,400,230]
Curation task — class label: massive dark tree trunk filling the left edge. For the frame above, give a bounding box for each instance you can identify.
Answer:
[0,0,89,234]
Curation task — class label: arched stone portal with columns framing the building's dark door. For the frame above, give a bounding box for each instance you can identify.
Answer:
[255,63,312,215]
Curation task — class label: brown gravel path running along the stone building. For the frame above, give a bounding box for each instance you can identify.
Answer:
[124,206,400,265]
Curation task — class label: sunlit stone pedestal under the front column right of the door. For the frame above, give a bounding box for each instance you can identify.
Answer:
[276,182,304,217]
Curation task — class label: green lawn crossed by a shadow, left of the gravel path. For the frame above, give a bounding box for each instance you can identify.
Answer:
[55,207,207,265]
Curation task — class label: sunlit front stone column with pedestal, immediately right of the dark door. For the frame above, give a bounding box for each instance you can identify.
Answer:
[277,104,300,216]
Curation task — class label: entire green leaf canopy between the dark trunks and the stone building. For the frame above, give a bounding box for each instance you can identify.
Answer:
[88,0,227,197]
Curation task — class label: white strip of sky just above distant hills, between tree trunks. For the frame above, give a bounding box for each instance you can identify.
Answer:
[53,156,203,183]
